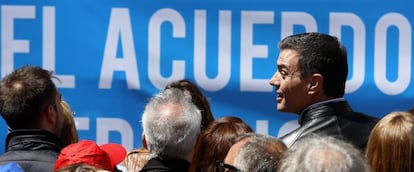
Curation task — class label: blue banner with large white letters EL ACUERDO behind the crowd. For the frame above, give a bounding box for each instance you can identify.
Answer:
[0,0,414,151]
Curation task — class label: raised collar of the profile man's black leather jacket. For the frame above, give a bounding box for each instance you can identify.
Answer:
[298,98,352,125]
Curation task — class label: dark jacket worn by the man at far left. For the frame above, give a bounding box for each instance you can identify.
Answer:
[0,129,62,172]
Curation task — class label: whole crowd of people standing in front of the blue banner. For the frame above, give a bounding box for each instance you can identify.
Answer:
[0,32,414,172]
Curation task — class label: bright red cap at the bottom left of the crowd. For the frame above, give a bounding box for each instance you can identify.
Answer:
[54,140,126,171]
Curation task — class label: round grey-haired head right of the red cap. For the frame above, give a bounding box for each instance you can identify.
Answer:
[142,88,201,159]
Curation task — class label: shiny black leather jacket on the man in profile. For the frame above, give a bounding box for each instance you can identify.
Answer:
[281,100,379,151]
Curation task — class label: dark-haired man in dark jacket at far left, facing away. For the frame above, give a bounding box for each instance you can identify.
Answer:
[0,66,64,172]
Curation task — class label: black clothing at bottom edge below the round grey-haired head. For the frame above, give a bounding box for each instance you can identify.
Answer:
[140,158,190,172]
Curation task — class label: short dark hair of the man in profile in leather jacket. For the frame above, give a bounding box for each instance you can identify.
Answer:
[279,32,348,97]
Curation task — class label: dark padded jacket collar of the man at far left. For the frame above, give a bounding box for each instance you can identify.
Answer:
[6,129,62,152]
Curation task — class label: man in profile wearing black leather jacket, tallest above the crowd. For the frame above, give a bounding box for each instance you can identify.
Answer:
[270,32,378,150]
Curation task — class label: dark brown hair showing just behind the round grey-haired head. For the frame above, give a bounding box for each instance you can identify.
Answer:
[165,79,214,131]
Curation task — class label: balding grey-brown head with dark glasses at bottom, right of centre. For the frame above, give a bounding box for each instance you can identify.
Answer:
[233,134,287,172]
